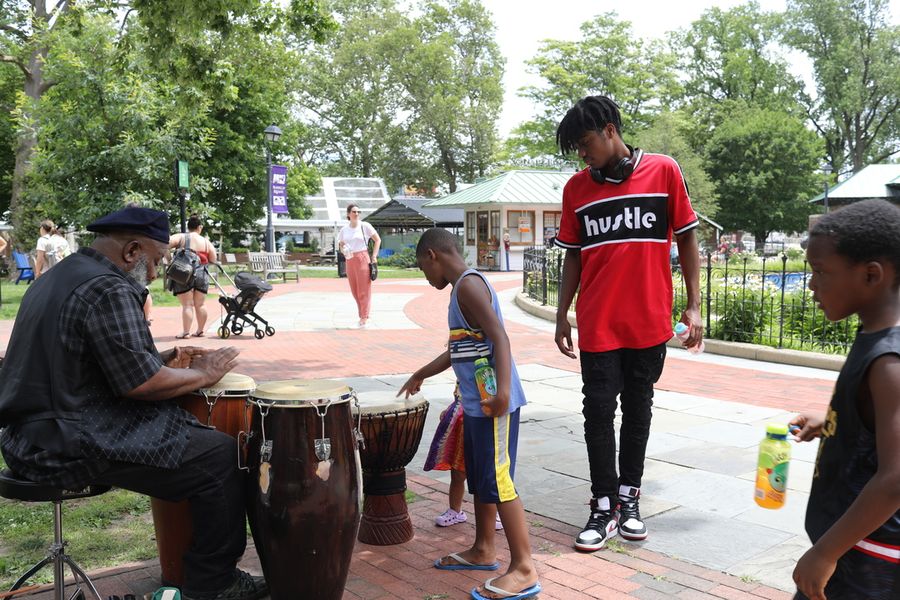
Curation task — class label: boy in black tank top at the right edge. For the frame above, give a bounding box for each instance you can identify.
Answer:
[791,200,900,600]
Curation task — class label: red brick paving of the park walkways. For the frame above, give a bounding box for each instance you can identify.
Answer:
[0,279,833,600]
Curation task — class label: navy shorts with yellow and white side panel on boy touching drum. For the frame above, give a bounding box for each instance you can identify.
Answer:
[463,409,519,504]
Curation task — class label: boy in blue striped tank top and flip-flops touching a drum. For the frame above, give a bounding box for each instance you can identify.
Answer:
[397,228,541,600]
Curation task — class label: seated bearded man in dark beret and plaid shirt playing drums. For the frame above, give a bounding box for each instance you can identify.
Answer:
[0,207,268,600]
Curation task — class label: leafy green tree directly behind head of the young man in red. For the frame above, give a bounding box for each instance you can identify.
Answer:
[506,12,680,158]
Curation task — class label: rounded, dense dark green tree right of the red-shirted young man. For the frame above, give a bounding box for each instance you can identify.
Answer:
[706,102,822,248]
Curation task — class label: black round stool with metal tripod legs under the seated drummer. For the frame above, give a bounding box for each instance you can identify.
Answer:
[0,469,110,600]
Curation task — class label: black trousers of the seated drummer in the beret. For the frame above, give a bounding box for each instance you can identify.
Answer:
[94,425,247,595]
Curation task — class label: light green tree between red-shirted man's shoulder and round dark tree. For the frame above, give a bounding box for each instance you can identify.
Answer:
[633,112,719,219]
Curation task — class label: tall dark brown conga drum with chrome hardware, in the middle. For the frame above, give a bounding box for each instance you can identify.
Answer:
[247,380,362,600]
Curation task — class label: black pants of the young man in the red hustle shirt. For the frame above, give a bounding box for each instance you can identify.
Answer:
[581,343,666,505]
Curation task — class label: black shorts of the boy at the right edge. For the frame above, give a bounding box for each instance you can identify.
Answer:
[794,548,900,600]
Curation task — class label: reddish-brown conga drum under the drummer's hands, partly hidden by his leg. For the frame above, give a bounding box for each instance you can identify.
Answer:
[150,373,256,586]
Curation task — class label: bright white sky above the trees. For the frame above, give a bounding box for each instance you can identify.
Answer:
[481,0,900,137]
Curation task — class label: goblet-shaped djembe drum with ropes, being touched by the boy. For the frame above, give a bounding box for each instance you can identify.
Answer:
[358,391,428,546]
